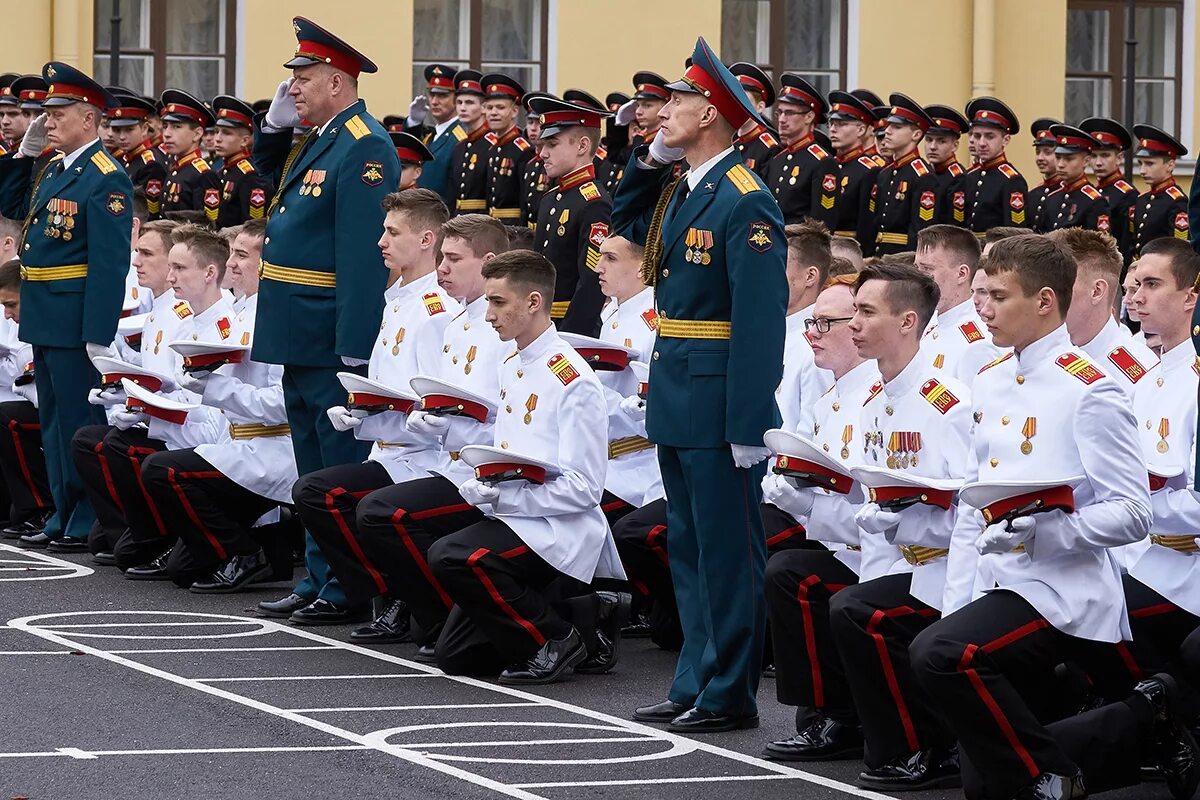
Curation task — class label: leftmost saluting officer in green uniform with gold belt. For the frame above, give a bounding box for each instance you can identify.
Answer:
[0,61,133,551]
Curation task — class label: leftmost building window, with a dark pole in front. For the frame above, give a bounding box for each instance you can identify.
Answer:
[94,0,236,100]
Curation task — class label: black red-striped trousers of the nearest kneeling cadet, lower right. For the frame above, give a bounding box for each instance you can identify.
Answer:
[910,591,1135,800]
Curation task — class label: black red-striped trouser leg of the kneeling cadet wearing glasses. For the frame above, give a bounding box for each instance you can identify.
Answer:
[766,549,858,723]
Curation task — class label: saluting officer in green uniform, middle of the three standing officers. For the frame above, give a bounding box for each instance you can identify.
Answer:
[253,17,400,624]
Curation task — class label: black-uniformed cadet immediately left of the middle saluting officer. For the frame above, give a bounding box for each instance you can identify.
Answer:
[204,95,275,228]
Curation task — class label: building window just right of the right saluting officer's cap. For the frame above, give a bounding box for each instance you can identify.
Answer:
[721,0,847,94]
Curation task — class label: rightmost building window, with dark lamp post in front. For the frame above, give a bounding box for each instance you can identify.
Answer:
[1066,0,1183,136]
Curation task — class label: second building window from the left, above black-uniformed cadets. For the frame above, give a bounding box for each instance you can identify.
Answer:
[413,0,550,101]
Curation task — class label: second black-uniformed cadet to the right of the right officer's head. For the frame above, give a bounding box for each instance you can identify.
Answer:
[760,72,838,227]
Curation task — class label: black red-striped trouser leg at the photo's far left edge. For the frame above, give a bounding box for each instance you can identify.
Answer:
[0,401,54,524]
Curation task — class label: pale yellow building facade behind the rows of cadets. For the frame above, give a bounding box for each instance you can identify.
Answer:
[0,0,1200,184]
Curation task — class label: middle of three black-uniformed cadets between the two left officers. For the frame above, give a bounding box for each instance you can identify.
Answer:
[162,89,215,213]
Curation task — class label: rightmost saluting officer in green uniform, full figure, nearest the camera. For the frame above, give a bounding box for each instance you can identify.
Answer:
[613,38,787,733]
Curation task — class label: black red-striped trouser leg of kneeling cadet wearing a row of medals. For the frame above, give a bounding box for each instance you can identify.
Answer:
[829,567,953,769]
